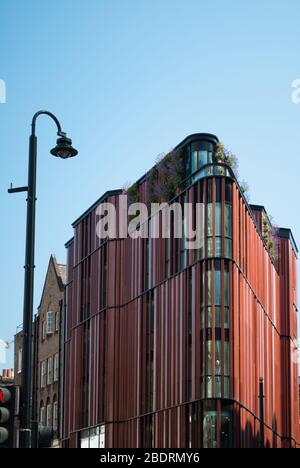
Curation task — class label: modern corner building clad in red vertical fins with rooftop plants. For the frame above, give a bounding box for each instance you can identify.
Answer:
[62,134,300,448]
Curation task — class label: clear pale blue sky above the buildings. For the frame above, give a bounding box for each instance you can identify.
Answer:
[0,0,300,368]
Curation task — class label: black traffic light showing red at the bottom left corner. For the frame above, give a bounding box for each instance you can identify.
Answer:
[0,386,15,448]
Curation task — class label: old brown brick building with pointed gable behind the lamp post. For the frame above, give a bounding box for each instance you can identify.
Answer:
[15,255,66,448]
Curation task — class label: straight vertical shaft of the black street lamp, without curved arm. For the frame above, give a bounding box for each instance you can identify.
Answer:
[20,132,37,448]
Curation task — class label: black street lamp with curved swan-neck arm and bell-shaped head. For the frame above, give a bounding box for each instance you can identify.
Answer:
[8,111,78,448]
